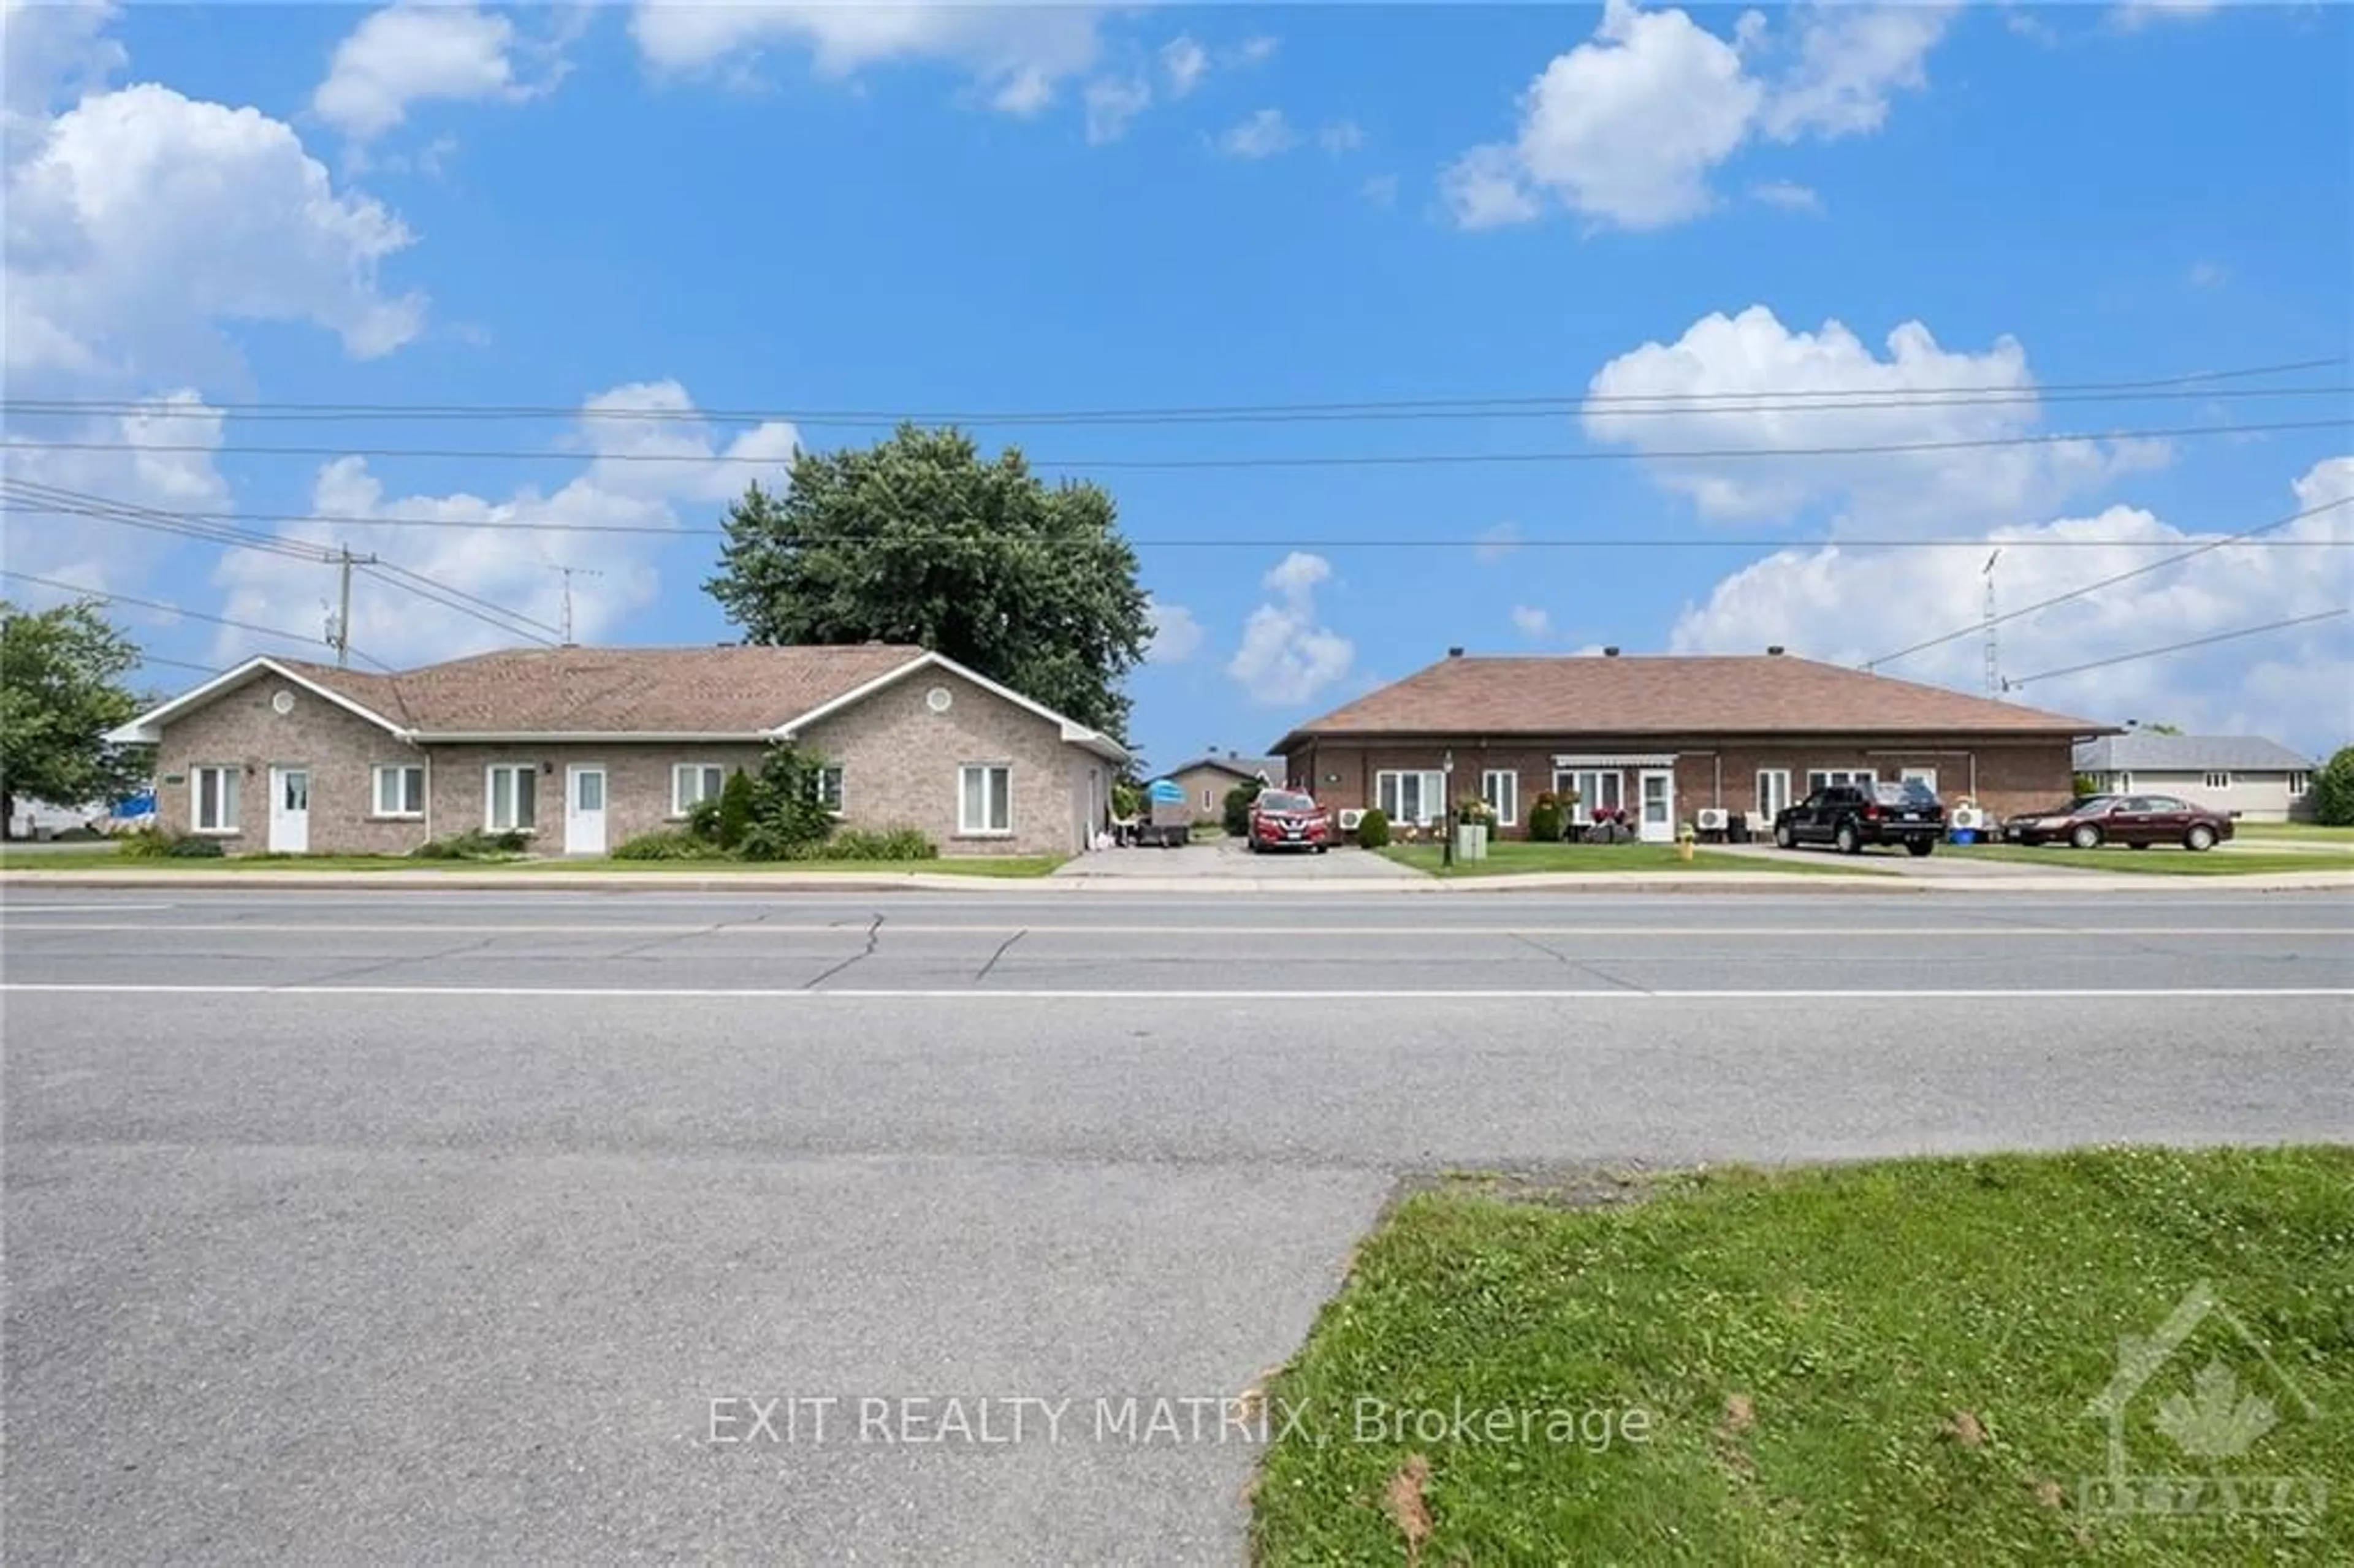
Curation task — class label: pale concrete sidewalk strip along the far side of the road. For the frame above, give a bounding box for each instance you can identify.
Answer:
[0,866,2354,897]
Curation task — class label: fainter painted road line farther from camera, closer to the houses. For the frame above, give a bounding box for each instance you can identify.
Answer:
[0,916,2354,942]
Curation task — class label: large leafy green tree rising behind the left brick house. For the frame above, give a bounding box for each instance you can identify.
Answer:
[704,424,1151,737]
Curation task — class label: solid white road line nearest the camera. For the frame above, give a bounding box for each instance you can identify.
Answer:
[0,980,2354,1003]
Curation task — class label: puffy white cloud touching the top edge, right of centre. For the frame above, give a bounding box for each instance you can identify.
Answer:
[1441,0,1956,229]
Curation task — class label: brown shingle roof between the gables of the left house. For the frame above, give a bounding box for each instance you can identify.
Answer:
[278,643,923,734]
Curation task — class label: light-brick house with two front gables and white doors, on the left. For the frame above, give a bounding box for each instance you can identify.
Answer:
[109,643,1127,854]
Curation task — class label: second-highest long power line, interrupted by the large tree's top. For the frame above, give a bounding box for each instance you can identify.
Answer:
[0,419,2354,473]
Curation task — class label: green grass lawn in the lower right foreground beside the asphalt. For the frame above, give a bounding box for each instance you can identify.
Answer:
[1252,1149,2354,1568]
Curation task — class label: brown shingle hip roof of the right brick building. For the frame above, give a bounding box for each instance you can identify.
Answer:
[1276,655,2111,751]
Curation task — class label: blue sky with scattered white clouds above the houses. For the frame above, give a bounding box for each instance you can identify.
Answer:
[5,5,2354,763]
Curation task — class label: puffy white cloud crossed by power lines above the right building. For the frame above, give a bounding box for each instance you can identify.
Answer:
[1582,306,2166,530]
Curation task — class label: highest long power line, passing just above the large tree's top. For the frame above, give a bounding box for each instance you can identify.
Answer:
[0,356,2345,424]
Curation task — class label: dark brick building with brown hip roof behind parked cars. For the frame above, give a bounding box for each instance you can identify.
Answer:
[1276,650,2114,840]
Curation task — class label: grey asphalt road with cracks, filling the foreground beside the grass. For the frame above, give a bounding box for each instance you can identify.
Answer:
[0,888,2354,1566]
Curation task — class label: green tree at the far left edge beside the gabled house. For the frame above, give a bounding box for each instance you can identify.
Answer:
[0,600,146,824]
